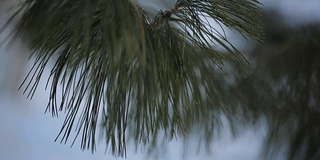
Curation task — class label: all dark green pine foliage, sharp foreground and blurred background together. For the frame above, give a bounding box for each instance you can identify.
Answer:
[3,0,320,160]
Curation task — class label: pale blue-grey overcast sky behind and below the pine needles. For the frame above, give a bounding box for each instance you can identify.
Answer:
[0,0,320,160]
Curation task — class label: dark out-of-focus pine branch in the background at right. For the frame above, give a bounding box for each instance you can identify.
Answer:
[241,11,320,160]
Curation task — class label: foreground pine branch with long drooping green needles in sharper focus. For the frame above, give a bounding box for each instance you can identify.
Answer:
[1,0,262,156]
